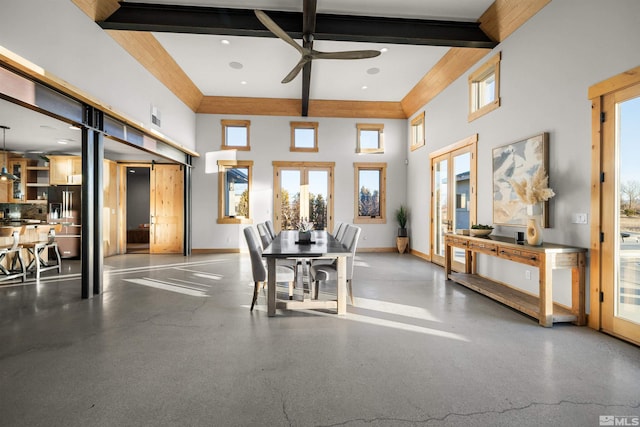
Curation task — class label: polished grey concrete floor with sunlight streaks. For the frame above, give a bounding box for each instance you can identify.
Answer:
[0,254,640,426]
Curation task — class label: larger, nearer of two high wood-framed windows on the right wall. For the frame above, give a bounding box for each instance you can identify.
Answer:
[469,53,500,121]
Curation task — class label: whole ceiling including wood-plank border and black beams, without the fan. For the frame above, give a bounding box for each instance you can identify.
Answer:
[72,0,550,118]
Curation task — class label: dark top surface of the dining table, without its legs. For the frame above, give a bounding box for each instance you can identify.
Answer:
[262,230,351,258]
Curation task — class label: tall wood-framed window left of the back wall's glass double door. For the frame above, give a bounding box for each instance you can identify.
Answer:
[218,160,253,224]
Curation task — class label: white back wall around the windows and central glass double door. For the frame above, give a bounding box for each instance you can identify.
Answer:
[193,114,407,249]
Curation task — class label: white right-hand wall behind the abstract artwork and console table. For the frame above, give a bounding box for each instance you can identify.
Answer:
[408,0,640,304]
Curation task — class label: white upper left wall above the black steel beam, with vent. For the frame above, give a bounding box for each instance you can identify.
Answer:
[0,0,196,149]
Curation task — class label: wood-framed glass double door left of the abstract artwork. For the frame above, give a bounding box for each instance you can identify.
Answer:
[430,135,478,271]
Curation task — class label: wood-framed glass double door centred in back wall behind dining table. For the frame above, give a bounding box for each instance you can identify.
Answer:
[273,162,335,231]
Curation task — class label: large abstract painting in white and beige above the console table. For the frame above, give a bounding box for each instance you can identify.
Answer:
[492,132,549,228]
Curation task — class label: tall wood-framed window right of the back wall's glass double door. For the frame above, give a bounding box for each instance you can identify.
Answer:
[353,163,387,224]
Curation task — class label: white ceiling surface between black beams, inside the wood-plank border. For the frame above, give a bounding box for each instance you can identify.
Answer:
[102,0,493,102]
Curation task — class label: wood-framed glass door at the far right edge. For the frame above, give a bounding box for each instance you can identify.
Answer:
[600,83,640,343]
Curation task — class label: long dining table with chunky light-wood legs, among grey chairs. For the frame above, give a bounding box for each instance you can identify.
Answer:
[262,230,352,317]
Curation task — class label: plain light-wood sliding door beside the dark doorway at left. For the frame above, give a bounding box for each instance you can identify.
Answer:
[149,164,184,254]
